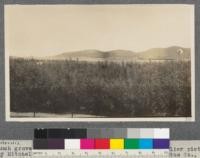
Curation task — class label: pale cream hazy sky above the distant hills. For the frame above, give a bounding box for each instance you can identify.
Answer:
[5,5,194,56]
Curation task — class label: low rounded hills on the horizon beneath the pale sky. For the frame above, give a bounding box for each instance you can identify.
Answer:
[10,46,191,62]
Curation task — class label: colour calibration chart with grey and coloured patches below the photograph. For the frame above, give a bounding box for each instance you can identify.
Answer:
[33,128,170,158]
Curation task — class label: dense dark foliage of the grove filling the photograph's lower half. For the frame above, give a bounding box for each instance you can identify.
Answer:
[10,59,191,117]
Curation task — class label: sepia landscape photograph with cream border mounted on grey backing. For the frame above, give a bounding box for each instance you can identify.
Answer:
[4,4,195,121]
